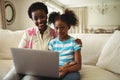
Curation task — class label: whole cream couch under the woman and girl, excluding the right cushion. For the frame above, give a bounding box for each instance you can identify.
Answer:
[0,30,120,80]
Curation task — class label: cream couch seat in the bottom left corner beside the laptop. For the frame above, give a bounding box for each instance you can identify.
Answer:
[0,60,13,80]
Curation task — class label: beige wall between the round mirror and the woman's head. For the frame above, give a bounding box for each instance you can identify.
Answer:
[7,0,58,30]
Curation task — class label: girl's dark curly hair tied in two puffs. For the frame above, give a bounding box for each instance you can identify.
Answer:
[48,9,78,26]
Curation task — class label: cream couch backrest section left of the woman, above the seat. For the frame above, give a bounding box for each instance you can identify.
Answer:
[0,30,24,59]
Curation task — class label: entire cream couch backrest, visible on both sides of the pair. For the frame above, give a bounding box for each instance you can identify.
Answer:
[0,30,112,65]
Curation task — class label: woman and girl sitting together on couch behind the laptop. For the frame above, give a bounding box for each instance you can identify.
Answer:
[3,2,81,80]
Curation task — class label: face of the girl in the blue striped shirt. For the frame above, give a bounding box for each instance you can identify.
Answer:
[54,20,69,41]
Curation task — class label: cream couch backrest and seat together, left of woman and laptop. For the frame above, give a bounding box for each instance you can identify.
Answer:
[0,29,24,80]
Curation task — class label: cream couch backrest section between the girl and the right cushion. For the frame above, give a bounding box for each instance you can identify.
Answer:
[70,34,112,65]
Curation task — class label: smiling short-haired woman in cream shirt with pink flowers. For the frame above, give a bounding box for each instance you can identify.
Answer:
[3,2,80,80]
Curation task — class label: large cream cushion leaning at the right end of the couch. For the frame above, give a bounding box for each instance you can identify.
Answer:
[96,31,120,74]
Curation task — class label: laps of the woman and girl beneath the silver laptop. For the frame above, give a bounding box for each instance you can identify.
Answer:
[4,68,80,80]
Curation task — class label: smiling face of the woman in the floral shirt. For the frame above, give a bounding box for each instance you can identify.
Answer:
[32,9,47,30]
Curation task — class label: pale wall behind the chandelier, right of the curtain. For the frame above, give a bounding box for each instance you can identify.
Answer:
[88,4,120,29]
